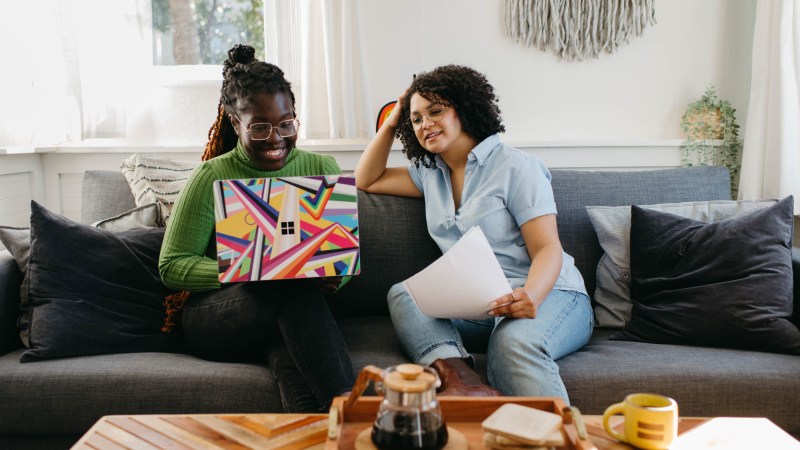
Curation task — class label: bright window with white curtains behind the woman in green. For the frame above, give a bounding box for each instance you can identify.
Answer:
[0,0,372,148]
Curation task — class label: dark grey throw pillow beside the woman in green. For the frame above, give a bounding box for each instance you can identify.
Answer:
[20,202,185,362]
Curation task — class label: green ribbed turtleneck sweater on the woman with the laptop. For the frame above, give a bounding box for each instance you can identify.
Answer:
[158,142,341,292]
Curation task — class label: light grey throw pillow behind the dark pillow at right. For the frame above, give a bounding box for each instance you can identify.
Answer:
[586,199,777,328]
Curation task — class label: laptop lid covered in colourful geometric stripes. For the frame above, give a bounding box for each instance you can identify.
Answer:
[214,175,361,283]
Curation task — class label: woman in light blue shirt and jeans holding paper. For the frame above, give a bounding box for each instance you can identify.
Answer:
[355,65,593,401]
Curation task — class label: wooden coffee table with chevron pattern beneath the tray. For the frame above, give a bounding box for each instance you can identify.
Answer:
[72,406,800,450]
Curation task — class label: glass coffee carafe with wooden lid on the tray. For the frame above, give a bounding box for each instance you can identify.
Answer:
[348,364,454,450]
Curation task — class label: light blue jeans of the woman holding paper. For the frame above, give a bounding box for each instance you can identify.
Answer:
[388,279,594,403]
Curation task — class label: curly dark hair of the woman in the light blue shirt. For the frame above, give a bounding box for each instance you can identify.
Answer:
[395,64,506,167]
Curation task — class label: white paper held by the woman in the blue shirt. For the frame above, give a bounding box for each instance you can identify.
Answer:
[403,227,511,319]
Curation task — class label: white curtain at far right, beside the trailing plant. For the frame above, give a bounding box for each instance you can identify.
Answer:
[739,0,800,214]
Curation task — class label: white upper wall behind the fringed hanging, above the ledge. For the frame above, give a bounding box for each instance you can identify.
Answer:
[358,0,755,142]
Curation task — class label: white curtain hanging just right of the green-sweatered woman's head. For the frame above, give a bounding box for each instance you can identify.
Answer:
[265,0,374,139]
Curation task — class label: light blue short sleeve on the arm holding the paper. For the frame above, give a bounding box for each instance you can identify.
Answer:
[507,155,557,227]
